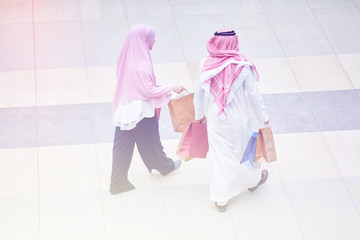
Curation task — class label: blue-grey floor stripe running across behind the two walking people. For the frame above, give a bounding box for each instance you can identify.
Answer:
[0,90,360,148]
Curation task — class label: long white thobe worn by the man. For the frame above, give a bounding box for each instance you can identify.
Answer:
[194,60,269,202]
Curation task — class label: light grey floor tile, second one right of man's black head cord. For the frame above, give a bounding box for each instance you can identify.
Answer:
[274,24,325,41]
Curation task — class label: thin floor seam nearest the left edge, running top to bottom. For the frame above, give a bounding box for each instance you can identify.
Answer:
[31,0,41,240]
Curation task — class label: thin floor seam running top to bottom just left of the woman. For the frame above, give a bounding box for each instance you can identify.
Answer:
[76,0,108,240]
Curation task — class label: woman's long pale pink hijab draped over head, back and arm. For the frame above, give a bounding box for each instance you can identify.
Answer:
[113,24,172,112]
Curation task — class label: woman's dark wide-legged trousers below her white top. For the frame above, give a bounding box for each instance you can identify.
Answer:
[110,115,175,194]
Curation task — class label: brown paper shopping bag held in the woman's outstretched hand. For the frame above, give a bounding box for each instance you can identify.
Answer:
[168,93,195,132]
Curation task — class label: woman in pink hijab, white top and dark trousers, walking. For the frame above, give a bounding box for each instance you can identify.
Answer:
[110,24,185,194]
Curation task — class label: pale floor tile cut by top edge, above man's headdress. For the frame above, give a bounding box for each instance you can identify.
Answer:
[215,0,264,14]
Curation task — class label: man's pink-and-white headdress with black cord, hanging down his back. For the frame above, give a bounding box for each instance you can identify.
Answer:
[202,29,259,115]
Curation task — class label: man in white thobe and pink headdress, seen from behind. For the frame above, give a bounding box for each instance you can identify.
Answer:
[194,29,269,212]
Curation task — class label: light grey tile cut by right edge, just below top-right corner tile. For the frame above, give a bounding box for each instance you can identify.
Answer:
[313,7,360,23]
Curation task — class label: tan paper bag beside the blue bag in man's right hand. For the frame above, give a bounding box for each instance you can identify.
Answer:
[255,127,277,162]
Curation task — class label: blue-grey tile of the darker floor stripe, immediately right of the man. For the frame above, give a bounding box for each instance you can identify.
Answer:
[263,94,319,133]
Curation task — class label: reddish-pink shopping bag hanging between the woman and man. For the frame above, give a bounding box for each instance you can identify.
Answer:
[176,121,209,161]
